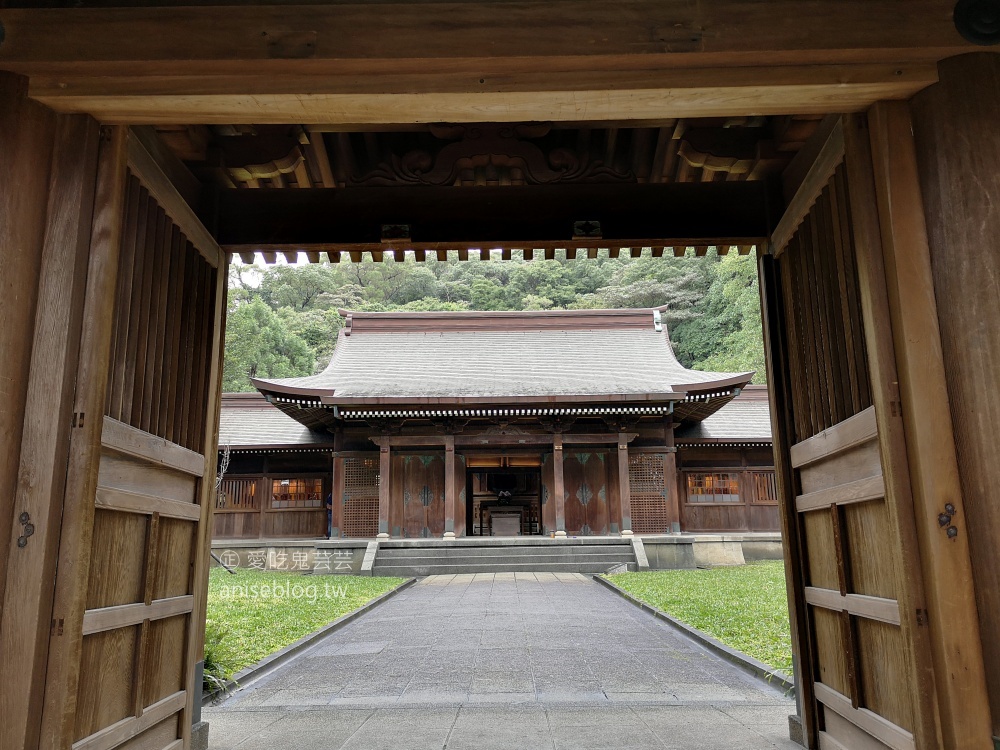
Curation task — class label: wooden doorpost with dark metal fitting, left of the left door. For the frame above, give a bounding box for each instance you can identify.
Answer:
[0,104,100,747]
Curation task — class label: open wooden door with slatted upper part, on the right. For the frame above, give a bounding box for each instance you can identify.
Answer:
[761,117,978,750]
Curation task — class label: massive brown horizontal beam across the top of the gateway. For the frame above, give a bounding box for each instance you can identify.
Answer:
[0,0,969,124]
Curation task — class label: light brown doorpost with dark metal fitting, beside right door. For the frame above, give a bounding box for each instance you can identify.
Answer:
[854,101,995,750]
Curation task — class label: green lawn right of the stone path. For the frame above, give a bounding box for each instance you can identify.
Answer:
[608,561,792,674]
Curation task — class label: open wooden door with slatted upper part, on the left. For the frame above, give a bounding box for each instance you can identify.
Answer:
[41,128,226,750]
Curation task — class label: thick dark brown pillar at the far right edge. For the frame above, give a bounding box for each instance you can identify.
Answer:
[912,53,1000,741]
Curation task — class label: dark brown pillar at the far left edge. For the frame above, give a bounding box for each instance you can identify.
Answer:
[0,73,55,616]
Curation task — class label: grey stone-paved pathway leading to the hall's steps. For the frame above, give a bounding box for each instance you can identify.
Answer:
[204,573,801,750]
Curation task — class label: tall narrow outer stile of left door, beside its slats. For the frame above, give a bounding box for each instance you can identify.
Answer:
[38,127,127,749]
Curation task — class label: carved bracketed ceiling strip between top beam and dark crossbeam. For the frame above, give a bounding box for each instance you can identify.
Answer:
[157,115,821,188]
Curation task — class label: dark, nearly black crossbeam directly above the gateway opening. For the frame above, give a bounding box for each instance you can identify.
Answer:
[217,182,770,248]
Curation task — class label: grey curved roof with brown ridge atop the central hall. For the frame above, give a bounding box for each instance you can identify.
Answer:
[254,309,753,403]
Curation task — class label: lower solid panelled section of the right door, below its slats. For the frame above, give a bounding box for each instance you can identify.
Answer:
[791,406,913,746]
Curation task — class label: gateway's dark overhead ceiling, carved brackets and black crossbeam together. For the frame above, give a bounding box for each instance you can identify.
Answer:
[156,115,820,262]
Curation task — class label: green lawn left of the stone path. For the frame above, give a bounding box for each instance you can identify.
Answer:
[205,568,404,678]
